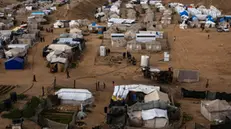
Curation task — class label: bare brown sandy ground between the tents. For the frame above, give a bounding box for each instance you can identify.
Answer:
[0,1,231,129]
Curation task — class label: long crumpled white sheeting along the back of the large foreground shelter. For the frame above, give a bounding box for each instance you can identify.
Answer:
[113,84,160,99]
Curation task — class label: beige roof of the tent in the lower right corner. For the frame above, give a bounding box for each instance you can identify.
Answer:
[201,99,231,112]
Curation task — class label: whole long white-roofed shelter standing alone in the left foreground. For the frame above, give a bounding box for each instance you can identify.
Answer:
[55,88,94,106]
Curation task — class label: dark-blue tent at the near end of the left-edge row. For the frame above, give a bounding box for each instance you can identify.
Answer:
[5,57,24,70]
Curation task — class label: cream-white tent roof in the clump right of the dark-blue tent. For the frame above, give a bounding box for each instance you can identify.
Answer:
[48,44,72,53]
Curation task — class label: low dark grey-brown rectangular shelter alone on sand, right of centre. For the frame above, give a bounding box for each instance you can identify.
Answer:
[177,70,199,83]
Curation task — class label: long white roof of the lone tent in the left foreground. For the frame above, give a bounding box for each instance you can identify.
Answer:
[55,88,93,101]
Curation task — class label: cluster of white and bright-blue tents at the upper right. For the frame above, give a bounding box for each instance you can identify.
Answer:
[169,3,230,29]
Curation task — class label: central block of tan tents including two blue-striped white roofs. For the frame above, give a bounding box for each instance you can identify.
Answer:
[99,0,168,52]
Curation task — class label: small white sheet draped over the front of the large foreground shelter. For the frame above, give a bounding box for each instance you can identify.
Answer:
[142,109,168,120]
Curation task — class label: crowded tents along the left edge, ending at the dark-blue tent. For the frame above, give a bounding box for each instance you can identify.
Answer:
[0,0,68,70]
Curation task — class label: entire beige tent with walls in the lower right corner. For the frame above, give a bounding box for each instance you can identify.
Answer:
[201,99,231,121]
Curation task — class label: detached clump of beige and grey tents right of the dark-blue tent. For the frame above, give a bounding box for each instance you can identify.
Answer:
[43,19,87,72]
